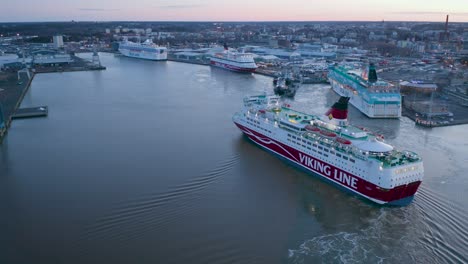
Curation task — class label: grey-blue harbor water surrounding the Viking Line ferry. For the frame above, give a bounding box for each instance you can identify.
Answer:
[0,54,468,263]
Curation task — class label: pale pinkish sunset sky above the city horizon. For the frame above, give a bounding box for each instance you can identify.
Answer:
[0,0,468,22]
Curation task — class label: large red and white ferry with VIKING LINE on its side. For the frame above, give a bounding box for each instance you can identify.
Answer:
[232,94,424,205]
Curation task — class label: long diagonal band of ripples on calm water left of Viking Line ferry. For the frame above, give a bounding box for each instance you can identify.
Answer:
[77,155,239,255]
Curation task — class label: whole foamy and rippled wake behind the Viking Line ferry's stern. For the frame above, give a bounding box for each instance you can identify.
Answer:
[288,188,468,263]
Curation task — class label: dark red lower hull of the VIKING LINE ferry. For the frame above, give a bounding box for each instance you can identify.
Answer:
[234,122,421,206]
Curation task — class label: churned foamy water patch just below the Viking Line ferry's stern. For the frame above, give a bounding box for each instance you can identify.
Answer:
[288,208,431,263]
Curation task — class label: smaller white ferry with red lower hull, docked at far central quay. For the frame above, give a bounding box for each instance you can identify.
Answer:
[210,44,257,73]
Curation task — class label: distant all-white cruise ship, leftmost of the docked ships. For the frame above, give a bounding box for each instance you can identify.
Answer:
[119,39,167,60]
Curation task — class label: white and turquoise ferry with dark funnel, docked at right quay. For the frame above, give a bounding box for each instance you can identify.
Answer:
[328,63,401,118]
